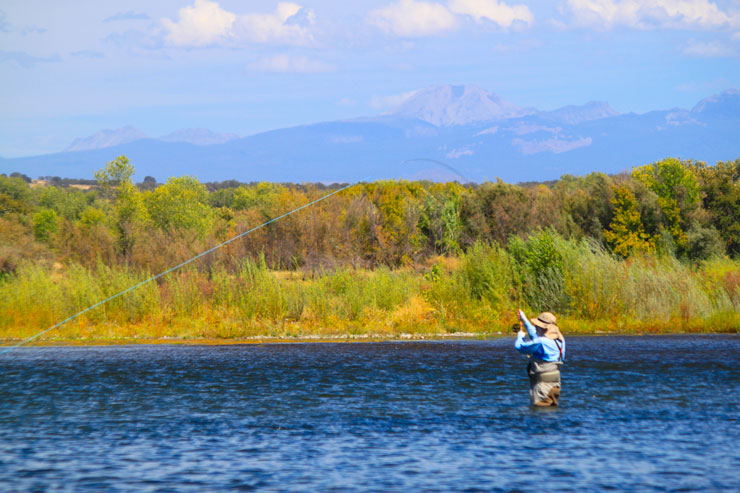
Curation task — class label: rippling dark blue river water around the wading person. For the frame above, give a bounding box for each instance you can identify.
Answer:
[0,336,740,491]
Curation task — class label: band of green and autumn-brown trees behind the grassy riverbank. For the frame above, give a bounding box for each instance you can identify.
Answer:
[0,156,740,275]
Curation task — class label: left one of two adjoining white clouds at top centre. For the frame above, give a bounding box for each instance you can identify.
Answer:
[369,0,458,38]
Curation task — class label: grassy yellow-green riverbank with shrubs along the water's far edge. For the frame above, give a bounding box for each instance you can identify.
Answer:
[0,236,740,342]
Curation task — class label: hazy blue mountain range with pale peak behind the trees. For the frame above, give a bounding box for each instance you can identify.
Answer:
[0,85,740,182]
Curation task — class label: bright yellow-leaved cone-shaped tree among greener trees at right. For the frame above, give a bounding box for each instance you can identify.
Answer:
[604,186,655,258]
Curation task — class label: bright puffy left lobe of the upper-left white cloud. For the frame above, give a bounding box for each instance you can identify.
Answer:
[162,0,236,46]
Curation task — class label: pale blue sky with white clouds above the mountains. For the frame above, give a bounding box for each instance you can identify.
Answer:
[0,0,740,157]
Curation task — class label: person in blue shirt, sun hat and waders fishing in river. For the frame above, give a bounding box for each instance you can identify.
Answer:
[514,308,565,406]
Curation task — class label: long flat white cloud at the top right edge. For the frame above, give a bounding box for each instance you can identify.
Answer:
[567,0,738,29]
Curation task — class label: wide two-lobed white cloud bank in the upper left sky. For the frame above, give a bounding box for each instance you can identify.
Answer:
[162,0,315,46]
